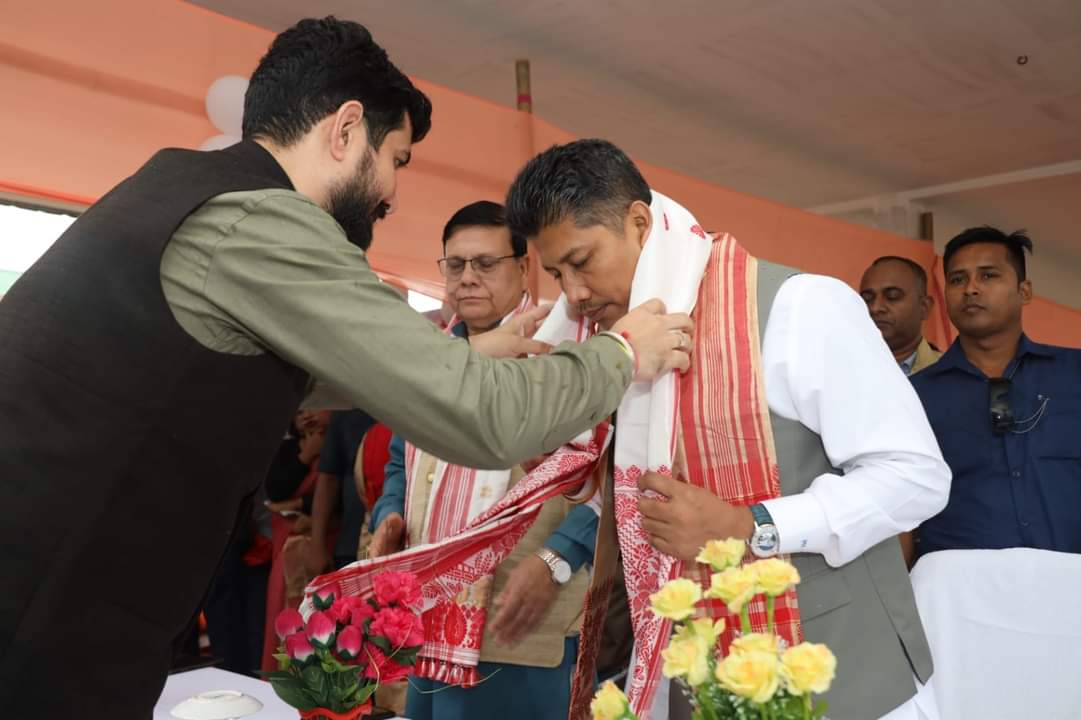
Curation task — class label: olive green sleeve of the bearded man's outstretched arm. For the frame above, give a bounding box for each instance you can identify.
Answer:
[204,192,632,468]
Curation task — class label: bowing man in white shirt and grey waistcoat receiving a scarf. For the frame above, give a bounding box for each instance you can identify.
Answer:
[507,141,950,720]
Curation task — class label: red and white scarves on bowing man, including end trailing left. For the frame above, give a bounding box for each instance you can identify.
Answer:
[308,191,799,720]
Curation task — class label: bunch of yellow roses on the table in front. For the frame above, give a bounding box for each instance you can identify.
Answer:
[591,538,837,720]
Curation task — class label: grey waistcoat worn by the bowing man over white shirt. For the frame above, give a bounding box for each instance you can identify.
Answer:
[758,261,933,720]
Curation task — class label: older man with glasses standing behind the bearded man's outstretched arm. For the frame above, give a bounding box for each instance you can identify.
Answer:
[370,201,598,720]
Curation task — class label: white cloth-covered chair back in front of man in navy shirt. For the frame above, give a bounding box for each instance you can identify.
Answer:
[912,548,1081,720]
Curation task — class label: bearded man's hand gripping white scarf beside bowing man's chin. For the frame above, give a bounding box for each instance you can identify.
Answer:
[612,298,694,381]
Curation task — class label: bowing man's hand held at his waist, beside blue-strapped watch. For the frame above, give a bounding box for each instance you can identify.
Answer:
[638,472,755,564]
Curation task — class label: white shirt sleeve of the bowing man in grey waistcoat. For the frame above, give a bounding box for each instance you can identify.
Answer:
[762,275,950,566]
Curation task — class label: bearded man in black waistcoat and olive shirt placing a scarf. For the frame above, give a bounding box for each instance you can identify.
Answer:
[0,17,690,720]
